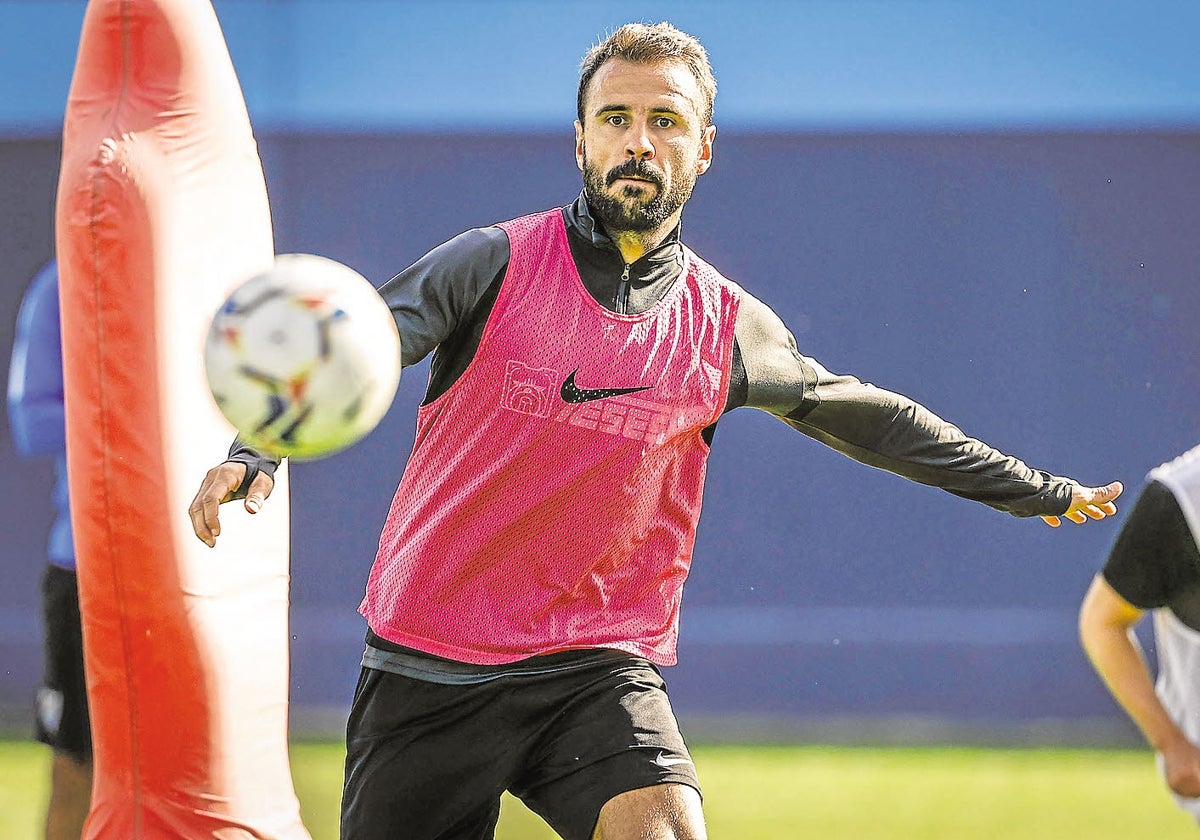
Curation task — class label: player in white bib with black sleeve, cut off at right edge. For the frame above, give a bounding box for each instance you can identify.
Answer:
[1079,446,1200,821]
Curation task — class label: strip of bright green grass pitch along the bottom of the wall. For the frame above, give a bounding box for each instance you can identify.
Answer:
[0,740,1196,840]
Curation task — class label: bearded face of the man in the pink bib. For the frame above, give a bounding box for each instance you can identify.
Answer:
[575,59,716,235]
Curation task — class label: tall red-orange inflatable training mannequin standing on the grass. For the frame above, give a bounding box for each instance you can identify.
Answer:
[56,0,308,840]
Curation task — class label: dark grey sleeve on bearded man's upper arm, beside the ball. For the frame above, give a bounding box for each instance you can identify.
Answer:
[379,227,510,367]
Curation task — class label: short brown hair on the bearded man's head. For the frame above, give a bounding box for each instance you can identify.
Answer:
[576,20,716,126]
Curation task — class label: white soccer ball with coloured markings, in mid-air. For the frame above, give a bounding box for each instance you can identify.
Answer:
[204,253,400,461]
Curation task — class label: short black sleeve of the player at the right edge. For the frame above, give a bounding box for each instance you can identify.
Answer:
[1100,481,1200,610]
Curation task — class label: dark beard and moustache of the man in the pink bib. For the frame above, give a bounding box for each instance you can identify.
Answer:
[583,157,696,236]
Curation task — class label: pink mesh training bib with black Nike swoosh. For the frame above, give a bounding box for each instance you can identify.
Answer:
[360,210,738,665]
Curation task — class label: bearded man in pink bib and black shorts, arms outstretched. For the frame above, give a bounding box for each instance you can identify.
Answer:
[190,24,1121,840]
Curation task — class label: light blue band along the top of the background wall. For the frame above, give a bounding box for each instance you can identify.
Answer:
[7,0,1200,136]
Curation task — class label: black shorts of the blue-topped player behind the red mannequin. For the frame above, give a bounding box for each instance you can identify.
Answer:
[34,564,91,762]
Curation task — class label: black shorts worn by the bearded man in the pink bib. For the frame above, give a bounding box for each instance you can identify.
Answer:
[341,656,700,840]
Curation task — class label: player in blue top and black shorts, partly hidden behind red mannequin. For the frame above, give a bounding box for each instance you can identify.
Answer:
[8,260,91,840]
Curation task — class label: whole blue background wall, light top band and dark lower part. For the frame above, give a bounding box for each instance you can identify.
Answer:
[0,0,1200,738]
